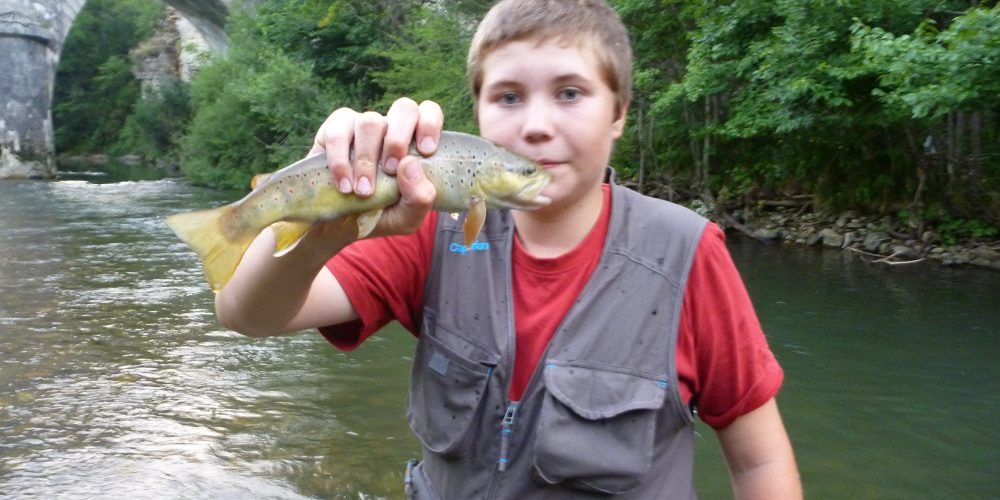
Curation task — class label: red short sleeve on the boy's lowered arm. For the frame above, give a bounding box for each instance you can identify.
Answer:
[677,224,784,429]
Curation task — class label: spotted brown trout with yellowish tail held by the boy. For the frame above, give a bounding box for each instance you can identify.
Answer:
[167,131,550,291]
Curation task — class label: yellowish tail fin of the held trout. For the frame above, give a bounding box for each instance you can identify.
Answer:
[167,207,255,292]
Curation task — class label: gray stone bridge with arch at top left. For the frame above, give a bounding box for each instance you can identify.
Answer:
[0,0,240,178]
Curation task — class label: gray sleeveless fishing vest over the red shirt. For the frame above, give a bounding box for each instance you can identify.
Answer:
[406,177,706,500]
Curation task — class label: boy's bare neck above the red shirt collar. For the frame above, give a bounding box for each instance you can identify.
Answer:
[512,185,604,259]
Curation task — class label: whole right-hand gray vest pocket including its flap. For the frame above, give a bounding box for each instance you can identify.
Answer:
[534,364,666,494]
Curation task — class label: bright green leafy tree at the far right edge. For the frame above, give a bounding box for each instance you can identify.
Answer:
[852,6,1000,220]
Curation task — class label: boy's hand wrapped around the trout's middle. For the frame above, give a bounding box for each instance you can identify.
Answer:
[310,97,444,235]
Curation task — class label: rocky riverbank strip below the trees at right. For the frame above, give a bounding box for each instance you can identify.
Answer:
[719,205,1000,271]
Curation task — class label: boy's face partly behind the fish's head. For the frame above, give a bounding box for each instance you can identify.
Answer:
[478,40,625,209]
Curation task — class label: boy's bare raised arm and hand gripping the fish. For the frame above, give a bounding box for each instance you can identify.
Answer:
[215,98,443,337]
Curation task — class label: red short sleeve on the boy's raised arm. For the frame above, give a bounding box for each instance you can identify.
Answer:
[319,212,437,351]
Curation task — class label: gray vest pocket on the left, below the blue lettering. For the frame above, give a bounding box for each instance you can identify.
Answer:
[407,311,496,456]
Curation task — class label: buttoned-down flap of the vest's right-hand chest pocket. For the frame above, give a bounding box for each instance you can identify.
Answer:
[545,363,667,420]
